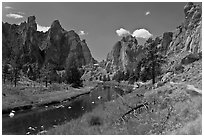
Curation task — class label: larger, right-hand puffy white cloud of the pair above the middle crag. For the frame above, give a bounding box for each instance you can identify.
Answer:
[132,29,153,39]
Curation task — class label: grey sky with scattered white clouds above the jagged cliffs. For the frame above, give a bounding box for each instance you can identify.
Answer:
[2,2,199,61]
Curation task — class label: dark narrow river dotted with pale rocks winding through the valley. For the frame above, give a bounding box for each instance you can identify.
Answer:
[2,85,131,135]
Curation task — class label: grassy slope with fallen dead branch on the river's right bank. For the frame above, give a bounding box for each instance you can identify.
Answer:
[46,79,202,135]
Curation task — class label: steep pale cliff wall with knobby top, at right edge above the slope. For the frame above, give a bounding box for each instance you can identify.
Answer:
[168,2,202,54]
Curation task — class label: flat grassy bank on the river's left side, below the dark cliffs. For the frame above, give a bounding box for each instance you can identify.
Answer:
[2,82,97,114]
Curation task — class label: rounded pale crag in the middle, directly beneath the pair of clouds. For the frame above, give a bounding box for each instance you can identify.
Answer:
[106,35,144,73]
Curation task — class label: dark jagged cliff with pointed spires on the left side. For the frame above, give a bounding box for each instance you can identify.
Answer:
[2,16,96,70]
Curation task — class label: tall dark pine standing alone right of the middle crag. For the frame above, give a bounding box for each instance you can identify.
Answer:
[138,38,166,84]
